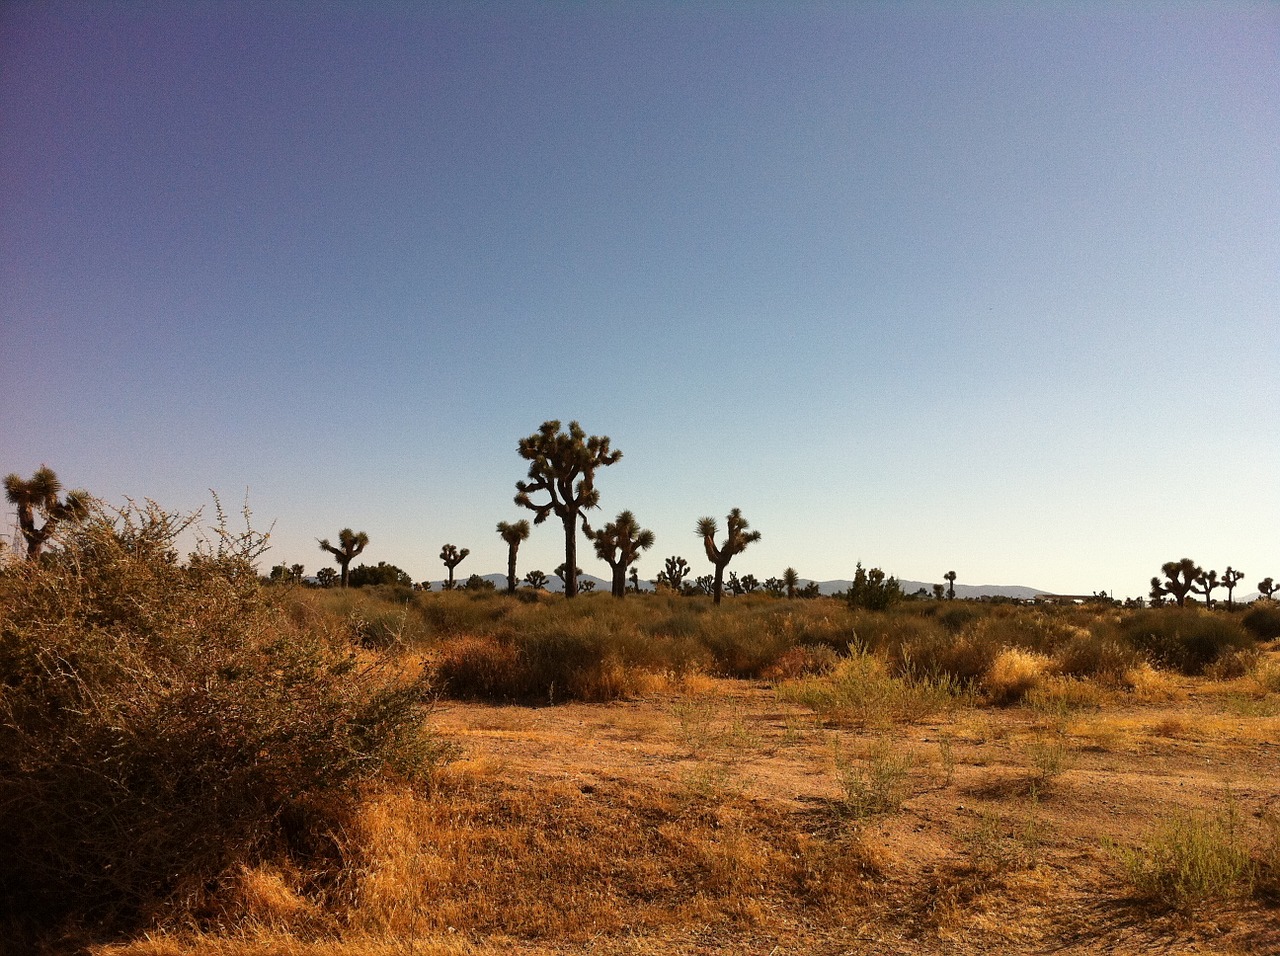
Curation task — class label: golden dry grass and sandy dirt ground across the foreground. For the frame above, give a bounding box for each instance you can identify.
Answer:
[92,662,1280,956]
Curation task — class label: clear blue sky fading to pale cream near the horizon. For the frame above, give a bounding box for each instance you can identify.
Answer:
[0,0,1280,596]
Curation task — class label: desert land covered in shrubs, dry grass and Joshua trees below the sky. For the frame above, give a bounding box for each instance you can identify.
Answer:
[0,458,1280,956]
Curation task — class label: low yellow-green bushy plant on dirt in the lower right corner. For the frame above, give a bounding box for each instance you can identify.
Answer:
[1110,801,1254,909]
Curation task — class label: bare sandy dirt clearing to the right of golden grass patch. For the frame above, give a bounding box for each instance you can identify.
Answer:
[419,678,1280,955]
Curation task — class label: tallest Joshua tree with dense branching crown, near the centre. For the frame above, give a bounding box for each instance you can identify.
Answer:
[516,420,622,598]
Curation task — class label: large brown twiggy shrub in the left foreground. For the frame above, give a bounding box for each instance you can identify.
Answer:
[0,504,439,921]
